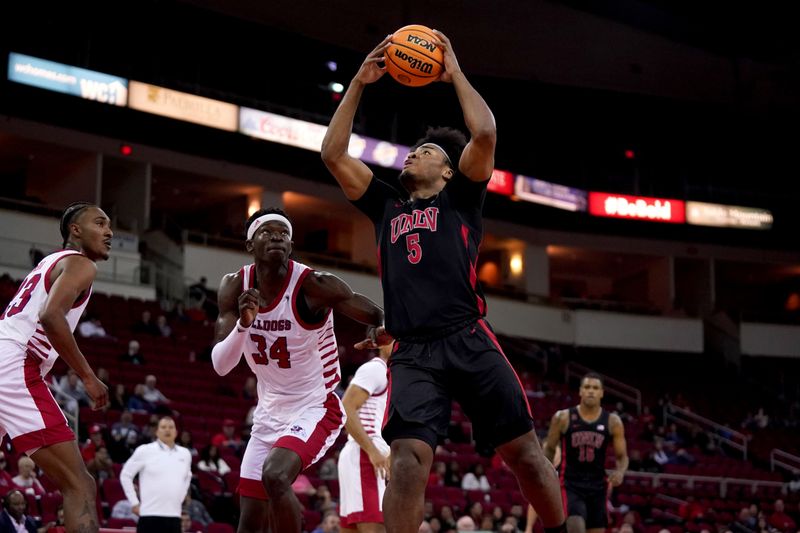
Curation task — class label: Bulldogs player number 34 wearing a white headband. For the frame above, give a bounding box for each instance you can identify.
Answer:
[211,209,390,533]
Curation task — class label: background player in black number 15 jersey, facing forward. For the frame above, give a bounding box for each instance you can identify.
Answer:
[544,374,628,533]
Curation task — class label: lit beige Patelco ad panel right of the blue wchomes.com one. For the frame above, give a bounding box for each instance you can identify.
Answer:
[129,80,239,131]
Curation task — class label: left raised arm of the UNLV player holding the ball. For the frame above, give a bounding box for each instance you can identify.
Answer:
[322,37,389,200]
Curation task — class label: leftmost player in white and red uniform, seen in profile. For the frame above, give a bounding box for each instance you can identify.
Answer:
[0,202,113,533]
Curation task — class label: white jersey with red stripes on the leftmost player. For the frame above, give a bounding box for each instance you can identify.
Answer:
[0,250,92,376]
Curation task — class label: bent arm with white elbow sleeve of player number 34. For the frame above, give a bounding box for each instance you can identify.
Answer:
[211,273,258,376]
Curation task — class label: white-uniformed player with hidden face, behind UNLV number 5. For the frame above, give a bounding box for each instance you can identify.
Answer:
[339,345,392,533]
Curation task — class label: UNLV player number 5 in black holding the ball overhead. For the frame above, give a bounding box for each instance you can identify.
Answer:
[322,32,564,533]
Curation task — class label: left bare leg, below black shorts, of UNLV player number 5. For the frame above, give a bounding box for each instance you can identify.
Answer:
[383,436,436,533]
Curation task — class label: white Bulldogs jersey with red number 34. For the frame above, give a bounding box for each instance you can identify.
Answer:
[240,260,341,431]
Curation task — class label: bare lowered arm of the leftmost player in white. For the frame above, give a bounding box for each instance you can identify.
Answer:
[39,254,108,409]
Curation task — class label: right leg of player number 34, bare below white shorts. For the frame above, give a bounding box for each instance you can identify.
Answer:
[261,447,303,533]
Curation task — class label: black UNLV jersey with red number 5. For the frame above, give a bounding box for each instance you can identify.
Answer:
[353,174,488,340]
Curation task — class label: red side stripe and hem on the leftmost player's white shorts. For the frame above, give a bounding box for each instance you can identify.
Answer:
[11,352,75,452]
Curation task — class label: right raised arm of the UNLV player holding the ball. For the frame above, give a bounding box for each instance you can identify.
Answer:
[433,30,497,181]
